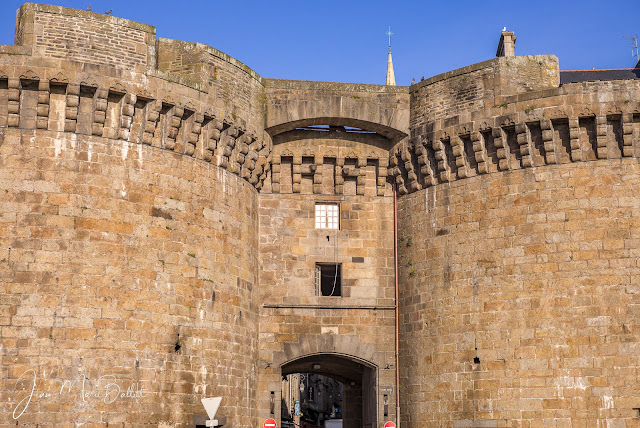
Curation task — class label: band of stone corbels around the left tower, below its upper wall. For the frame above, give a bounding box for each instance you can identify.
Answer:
[0,65,269,189]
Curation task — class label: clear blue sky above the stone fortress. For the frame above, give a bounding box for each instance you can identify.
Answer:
[0,0,640,85]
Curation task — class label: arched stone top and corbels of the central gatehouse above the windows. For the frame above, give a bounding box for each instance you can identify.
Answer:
[265,79,409,196]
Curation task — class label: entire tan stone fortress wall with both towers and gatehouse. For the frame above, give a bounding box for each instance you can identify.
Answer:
[0,4,640,427]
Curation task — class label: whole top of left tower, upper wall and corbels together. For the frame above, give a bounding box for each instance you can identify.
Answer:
[0,4,271,189]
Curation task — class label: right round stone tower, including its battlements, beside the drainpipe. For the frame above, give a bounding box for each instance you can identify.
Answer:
[392,57,640,427]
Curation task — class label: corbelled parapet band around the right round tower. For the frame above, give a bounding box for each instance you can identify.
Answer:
[390,69,640,194]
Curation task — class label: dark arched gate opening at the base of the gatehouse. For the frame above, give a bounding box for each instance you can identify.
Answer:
[281,353,377,428]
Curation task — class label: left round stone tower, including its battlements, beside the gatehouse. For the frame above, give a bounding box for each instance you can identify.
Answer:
[0,4,269,427]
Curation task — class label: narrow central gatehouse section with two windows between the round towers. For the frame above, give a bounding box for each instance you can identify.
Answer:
[258,79,408,428]
